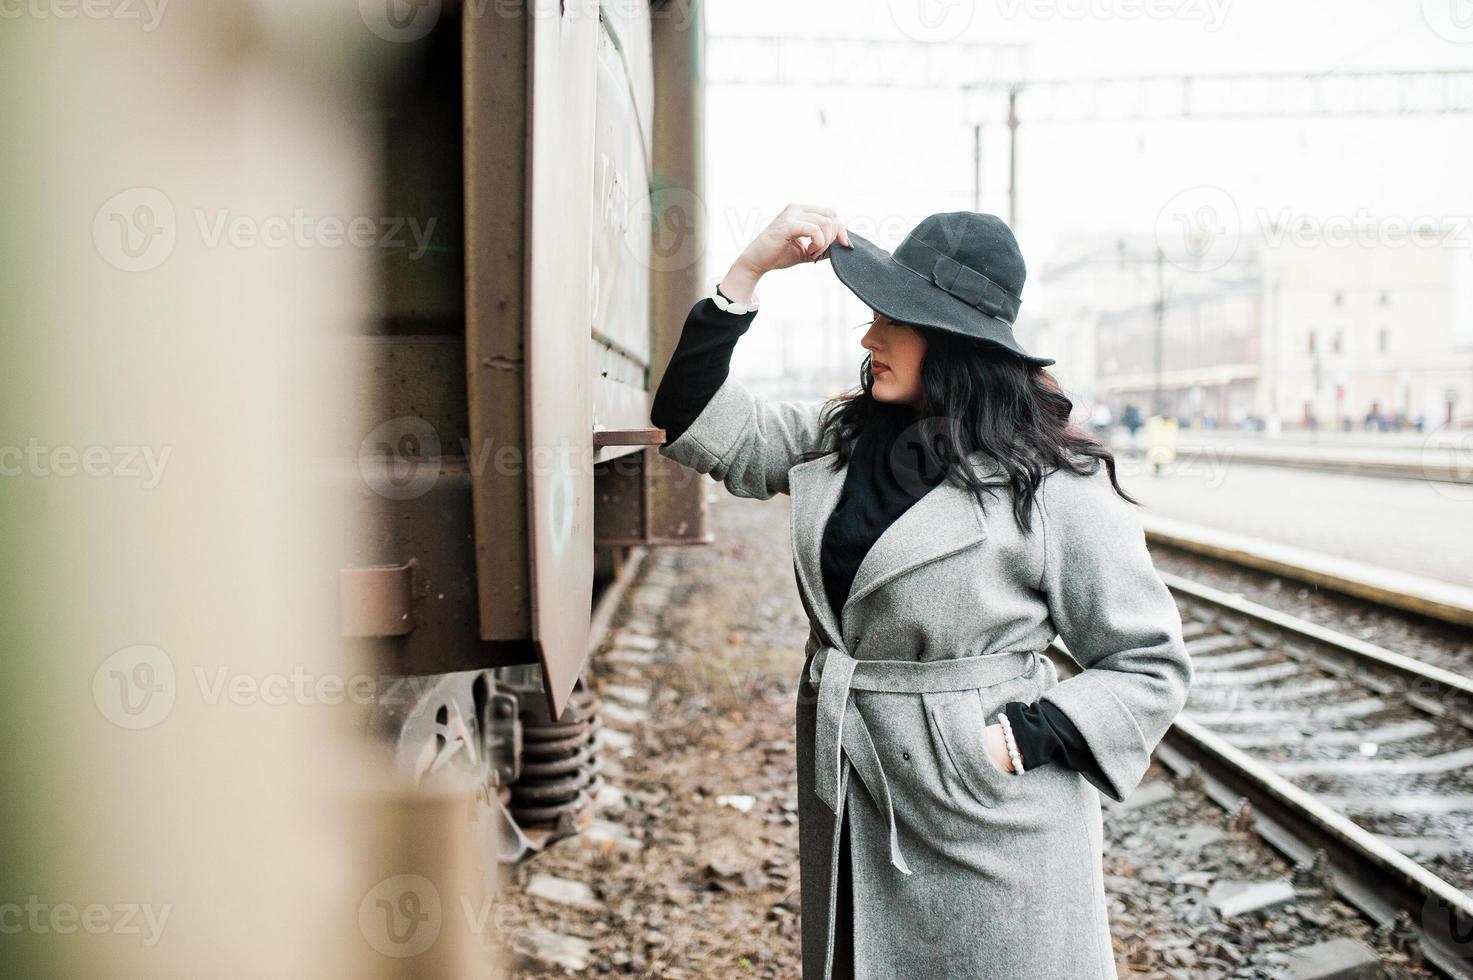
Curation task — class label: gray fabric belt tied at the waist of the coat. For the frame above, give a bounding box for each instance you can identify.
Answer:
[809,645,1041,874]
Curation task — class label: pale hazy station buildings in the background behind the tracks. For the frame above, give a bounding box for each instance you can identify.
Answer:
[1030,223,1473,430]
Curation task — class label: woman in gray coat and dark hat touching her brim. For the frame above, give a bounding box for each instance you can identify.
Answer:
[651,205,1192,980]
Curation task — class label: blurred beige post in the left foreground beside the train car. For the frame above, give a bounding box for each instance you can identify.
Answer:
[0,1,489,979]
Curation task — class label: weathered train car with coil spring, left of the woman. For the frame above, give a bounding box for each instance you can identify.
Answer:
[339,0,709,861]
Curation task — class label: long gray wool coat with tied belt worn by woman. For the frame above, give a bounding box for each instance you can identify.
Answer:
[660,377,1192,980]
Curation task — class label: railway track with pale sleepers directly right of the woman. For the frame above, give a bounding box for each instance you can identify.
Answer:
[1064,573,1473,977]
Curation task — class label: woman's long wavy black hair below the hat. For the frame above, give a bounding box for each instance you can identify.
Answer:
[804,324,1140,533]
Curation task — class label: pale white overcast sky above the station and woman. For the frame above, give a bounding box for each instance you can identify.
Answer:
[706,0,1473,389]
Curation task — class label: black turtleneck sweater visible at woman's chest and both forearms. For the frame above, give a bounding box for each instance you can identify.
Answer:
[650,298,1103,781]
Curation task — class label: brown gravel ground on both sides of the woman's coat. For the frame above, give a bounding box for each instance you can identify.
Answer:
[496,495,1436,979]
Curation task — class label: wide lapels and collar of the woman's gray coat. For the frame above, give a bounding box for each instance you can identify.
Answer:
[788,451,1008,651]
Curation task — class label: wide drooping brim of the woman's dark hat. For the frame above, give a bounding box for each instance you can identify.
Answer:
[828,231,1055,367]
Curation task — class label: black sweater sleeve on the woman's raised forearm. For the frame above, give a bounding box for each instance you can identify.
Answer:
[650,298,757,445]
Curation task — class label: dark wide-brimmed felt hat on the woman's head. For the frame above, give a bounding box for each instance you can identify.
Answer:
[826,211,1055,367]
